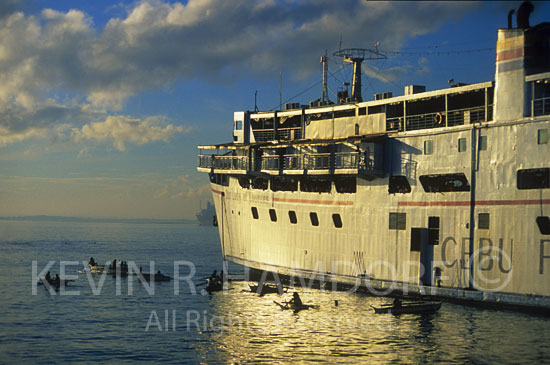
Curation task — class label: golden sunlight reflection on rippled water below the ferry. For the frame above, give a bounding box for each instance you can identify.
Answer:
[197,283,549,363]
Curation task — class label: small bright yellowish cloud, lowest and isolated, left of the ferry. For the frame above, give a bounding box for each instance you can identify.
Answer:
[71,116,189,152]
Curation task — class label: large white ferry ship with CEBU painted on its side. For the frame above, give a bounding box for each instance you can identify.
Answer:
[198,4,550,309]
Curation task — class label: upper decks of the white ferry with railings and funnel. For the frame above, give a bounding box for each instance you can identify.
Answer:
[198,23,550,176]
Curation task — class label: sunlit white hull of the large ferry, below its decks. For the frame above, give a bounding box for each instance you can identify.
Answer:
[211,117,550,308]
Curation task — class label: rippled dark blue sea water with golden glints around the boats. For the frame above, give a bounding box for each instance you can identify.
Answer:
[0,220,550,364]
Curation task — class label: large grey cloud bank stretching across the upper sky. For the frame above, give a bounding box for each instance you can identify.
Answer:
[0,0,479,150]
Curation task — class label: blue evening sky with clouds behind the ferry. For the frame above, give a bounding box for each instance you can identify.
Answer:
[0,0,550,219]
